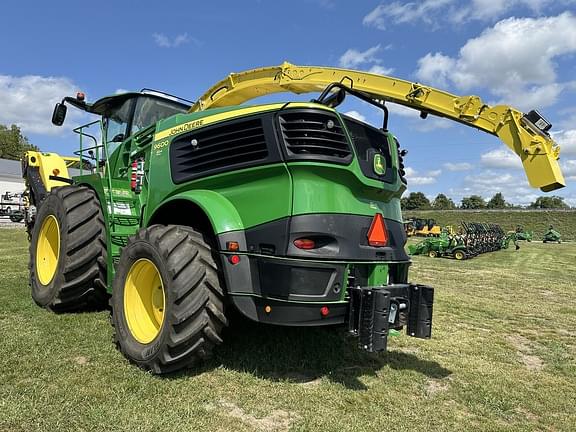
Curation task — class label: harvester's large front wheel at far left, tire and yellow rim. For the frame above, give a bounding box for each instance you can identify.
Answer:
[29,186,108,312]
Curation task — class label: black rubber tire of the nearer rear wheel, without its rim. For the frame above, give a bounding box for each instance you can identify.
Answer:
[111,225,228,374]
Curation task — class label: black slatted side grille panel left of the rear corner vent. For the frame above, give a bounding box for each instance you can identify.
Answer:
[170,118,268,183]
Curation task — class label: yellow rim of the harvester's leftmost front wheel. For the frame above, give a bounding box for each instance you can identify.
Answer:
[36,215,60,285]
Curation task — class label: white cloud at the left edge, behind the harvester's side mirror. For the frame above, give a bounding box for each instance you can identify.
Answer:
[0,75,82,135]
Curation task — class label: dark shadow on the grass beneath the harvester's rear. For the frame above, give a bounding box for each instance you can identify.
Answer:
[192,318,451,390]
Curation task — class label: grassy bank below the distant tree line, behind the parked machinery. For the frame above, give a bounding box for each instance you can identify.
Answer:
[403,210,576,240]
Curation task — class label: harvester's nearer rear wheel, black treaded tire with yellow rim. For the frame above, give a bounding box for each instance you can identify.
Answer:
[111,225,227,374]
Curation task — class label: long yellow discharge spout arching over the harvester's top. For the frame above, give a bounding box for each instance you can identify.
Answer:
[190,63,565,192]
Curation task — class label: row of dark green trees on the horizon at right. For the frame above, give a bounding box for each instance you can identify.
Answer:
[400,192,570,210]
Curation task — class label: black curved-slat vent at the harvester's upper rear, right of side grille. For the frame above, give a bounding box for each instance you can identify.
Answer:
[279,111,352,162]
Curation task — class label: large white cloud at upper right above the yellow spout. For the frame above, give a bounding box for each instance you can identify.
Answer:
[416,12,576,110]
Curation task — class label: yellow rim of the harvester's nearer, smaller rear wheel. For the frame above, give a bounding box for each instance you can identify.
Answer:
[124,258,166,344]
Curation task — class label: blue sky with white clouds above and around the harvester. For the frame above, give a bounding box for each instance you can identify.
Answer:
[0,0,576,206]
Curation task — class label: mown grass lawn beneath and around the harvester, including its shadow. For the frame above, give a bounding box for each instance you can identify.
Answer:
[0,229,576,432]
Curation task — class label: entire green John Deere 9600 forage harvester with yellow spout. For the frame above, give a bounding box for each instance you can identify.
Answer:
[23,63,564,373]
